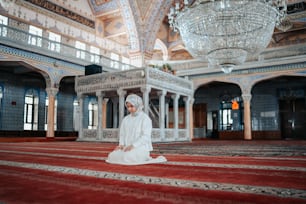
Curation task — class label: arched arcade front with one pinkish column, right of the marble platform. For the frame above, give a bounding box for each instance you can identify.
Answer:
[191,57,306,140]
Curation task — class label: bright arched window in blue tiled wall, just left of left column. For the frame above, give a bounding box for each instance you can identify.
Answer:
[24,89,39,130]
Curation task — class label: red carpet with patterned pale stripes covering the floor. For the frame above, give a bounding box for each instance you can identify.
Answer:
[0,141,306,204]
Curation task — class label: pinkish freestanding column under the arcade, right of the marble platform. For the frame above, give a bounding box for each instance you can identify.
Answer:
[242,94,252,140]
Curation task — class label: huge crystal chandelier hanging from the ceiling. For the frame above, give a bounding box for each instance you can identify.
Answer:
[168,0,287,73]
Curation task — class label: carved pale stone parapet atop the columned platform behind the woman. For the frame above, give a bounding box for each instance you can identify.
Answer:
[75,68,193,95]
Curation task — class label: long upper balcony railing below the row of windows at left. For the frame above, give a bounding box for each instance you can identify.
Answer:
[0,24,135,71]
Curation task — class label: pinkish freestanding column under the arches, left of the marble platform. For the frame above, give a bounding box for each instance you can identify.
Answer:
[46,88,58,139]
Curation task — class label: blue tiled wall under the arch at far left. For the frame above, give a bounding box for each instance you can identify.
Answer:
[0,72,75,131]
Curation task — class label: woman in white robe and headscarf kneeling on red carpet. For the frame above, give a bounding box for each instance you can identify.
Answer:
[106,94,167,165]
